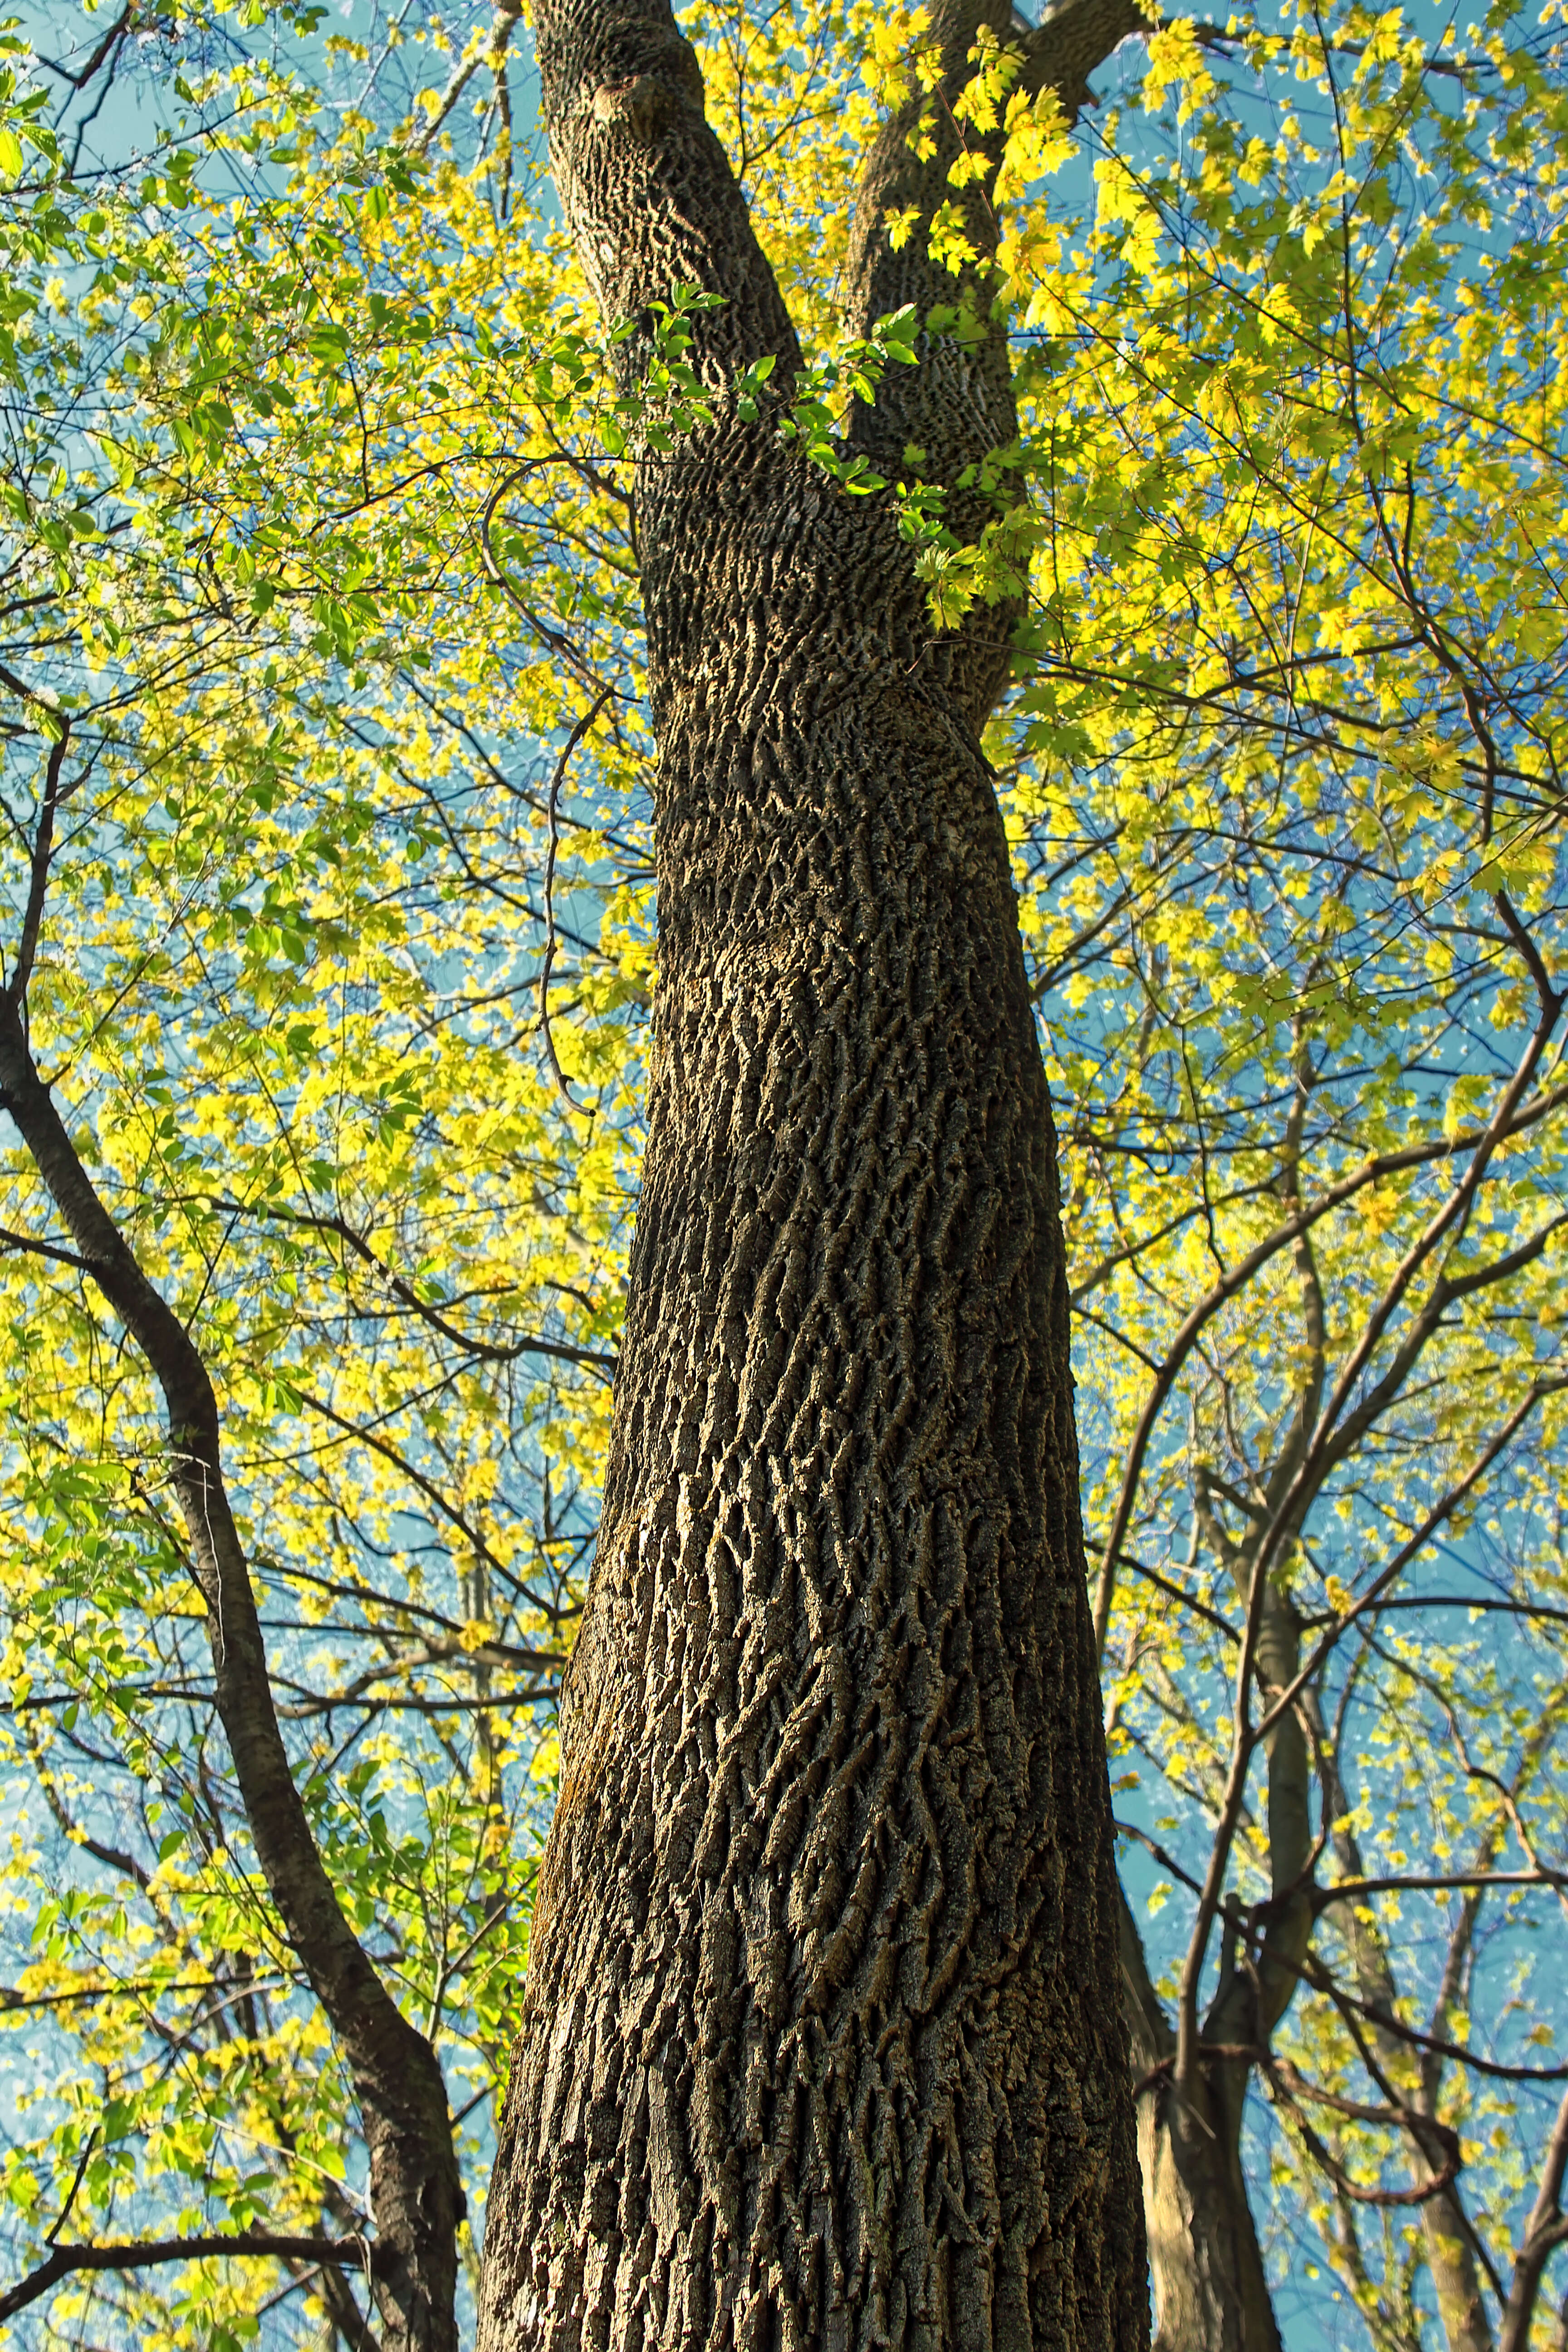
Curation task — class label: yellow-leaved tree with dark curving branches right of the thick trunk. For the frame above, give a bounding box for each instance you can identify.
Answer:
[987,12,1568,2347]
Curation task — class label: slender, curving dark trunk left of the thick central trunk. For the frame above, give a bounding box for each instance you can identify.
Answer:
[0,992,463,2352]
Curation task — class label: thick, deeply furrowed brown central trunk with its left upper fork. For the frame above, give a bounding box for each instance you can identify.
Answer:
[480,0,1147,2352]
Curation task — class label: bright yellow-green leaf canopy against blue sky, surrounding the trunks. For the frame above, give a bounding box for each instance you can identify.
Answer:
[0,0,1568,2345]
